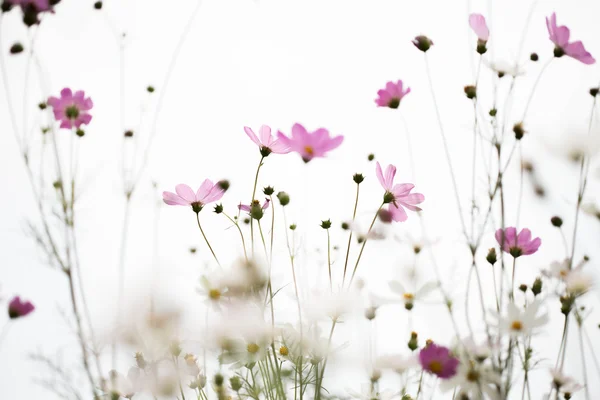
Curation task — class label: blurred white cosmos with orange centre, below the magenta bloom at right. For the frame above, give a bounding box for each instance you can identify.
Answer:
[498,300,548,337]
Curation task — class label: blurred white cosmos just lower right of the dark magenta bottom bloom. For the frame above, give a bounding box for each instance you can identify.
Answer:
[440,359,502,400]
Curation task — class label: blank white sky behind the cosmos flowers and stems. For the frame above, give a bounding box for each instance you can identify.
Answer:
[0,0,600,399]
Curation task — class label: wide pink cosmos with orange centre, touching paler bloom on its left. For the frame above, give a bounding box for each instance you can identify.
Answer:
[277,124,344,163]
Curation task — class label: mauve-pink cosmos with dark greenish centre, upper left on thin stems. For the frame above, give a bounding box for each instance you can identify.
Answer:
[48,88,94,129]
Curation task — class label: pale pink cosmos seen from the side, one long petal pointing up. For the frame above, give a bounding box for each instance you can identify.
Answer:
[376,162,425,222]
